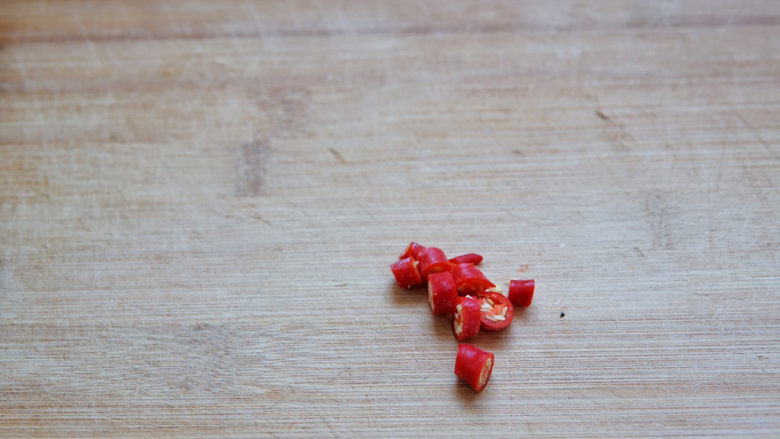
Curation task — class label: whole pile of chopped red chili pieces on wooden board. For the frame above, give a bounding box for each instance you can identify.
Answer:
[390,242,535,392]
